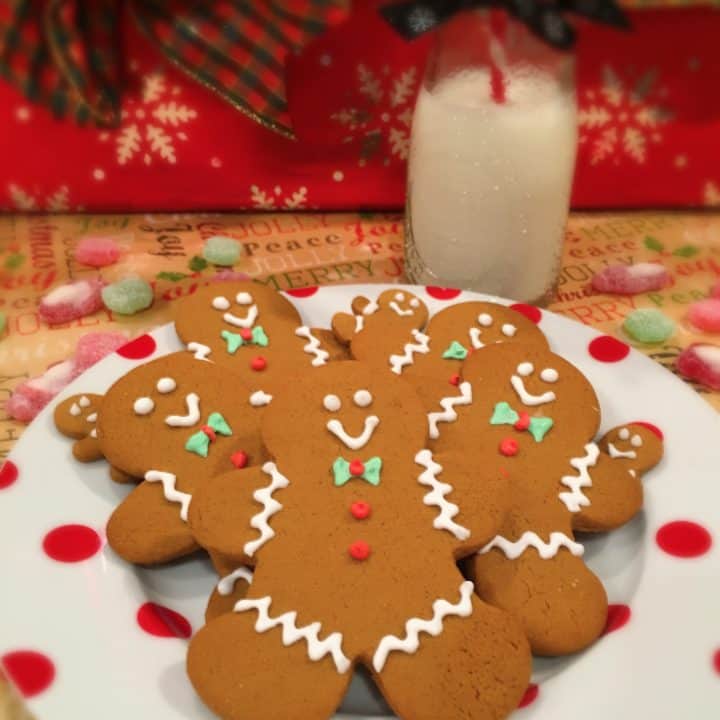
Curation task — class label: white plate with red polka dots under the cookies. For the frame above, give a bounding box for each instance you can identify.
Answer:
[0,285,720,720]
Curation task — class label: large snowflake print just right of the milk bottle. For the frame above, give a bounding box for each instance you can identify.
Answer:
[578,65,673,165]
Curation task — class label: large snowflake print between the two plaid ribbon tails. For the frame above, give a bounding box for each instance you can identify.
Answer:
[100,72,197,165]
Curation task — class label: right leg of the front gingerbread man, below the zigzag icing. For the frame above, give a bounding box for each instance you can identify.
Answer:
[375,596,531,720]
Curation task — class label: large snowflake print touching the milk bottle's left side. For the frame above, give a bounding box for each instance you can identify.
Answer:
[330,63,418,166]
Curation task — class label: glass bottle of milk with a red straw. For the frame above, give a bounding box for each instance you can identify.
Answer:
[405,10,577,303]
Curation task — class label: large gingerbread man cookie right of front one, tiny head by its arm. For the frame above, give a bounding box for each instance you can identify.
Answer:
[429,343,662,655]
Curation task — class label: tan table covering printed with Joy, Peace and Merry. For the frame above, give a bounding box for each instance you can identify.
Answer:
[0,212,720,720]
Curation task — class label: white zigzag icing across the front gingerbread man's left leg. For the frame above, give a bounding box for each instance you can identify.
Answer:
[235,595,351,673]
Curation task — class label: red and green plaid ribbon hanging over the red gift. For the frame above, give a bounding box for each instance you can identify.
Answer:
[0,0,348,137]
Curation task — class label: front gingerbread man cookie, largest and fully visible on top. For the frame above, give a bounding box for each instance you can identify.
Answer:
[188,362,530,720]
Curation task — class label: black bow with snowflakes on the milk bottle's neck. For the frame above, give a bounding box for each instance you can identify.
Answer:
[380,0,630,50]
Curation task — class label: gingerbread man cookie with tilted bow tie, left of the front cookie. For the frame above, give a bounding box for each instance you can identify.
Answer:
[98,353,265,564]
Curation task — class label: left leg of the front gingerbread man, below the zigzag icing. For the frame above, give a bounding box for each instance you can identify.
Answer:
[187,612,352,720]
